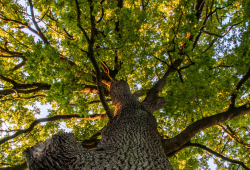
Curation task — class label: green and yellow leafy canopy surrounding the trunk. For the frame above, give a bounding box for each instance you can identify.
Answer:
[0,0,250,169]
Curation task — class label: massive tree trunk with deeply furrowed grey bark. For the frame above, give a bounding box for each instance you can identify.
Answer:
[24,81,172,170]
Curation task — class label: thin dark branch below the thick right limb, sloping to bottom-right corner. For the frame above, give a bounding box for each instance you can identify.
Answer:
[184,143,250,170]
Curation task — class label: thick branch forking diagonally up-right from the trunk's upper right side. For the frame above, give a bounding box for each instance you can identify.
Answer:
[142,59,182,112]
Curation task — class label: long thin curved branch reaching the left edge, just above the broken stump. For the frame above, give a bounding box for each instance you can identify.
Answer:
[0,114,106,145]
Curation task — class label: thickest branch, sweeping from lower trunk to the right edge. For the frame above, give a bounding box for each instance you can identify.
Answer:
[163,105,250,154]
